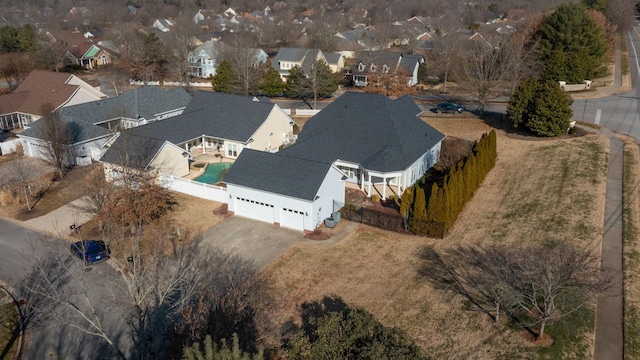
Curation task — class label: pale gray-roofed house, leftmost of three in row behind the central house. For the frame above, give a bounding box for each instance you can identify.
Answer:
[187,39,267,78]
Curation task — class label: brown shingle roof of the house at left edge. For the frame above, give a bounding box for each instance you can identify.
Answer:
[0,70,79,116]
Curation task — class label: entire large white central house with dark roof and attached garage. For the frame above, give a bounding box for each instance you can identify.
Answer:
[224,92,445,231]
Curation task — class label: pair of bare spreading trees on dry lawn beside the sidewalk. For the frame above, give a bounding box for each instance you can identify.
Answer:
[419,243,610,337]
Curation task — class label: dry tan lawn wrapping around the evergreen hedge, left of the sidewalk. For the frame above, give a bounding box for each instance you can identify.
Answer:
[262,118,608,359]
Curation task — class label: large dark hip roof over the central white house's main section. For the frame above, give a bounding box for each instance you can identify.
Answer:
[280,92,445,172]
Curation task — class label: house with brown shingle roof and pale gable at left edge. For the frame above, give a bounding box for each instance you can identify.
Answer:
[0,70,107,130]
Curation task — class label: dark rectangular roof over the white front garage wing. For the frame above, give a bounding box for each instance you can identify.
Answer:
[224,149,331,200]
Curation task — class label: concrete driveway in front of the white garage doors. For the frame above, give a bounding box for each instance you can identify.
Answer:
[198,215,304,269]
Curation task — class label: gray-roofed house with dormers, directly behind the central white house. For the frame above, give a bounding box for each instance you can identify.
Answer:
[351,51,424,87]
